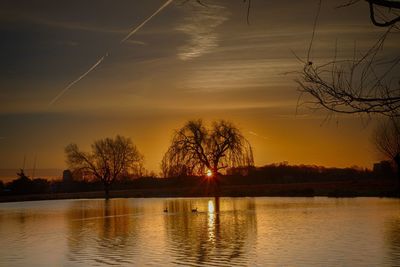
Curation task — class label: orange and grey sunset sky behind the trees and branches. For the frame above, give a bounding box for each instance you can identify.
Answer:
[0,0,400,180]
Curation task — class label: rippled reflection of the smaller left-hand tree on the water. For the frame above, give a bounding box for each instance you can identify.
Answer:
[67,200,138,264]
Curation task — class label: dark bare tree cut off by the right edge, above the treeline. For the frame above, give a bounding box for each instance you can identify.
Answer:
[373,117,400,181]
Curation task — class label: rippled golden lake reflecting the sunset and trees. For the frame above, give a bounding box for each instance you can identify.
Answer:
[0,197,400,266]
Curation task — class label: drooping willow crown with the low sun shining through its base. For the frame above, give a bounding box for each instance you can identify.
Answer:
[161,120,254,177]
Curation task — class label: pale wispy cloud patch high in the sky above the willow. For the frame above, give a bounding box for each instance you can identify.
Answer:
[175,5,229,60]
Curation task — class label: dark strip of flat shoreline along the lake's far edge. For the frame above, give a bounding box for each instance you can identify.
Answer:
[0,182,399,203]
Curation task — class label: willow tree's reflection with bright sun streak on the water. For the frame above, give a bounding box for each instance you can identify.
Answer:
[165,198,257,264]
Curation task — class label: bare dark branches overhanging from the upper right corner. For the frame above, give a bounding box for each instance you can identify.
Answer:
[296,0,400,116]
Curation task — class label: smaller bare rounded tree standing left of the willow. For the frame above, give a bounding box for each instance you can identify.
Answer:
[65,135,143,199]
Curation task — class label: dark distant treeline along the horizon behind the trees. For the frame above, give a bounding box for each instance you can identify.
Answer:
[0,163,396,196]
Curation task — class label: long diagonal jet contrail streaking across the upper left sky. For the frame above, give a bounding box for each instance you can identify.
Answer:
[49,0,174,106]
